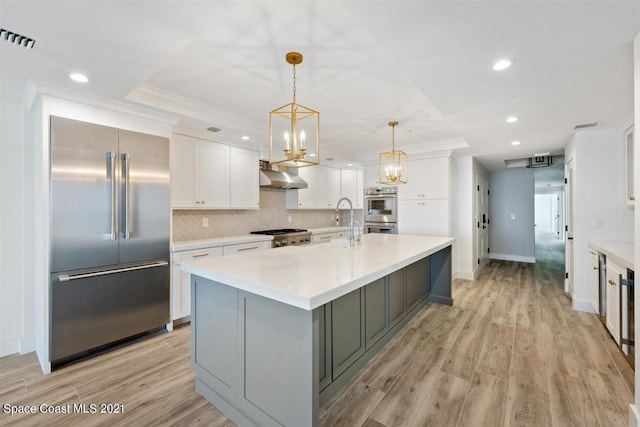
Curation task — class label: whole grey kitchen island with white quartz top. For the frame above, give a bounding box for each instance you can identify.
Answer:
[181,234,454,426]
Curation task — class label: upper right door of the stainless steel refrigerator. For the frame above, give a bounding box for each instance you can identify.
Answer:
[118,129,170,263]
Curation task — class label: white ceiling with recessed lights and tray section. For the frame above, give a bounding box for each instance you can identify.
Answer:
[0,0,640,178]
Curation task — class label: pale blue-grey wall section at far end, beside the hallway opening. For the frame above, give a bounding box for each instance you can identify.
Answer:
[489,168,535,262]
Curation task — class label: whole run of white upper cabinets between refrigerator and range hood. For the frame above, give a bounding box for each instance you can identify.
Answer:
[171,133,260,209]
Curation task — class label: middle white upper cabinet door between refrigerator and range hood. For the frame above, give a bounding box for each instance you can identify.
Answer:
[196,141,229,208]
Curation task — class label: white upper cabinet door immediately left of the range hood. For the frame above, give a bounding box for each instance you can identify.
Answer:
[229,147,260,209]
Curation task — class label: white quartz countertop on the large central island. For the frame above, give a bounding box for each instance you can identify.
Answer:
[181,234,455,310]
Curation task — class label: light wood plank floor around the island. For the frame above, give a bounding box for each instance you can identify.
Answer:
[0,261,634,427]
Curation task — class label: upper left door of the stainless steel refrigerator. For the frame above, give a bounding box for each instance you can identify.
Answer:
[50,117,119,272]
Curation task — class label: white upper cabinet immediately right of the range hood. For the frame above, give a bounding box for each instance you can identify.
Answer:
[287,165,355,209]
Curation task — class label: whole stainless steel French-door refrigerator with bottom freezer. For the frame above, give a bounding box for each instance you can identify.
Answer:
[50,116,170,366]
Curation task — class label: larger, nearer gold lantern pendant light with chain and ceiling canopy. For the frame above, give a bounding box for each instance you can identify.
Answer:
[269,52,320,168]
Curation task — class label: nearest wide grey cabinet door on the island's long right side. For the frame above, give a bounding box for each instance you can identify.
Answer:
[331,288,365,380]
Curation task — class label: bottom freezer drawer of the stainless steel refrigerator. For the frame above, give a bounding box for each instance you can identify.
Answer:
[51,262,169,364]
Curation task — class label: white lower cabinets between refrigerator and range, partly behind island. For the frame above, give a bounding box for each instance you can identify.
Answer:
[171,240,272,320]
